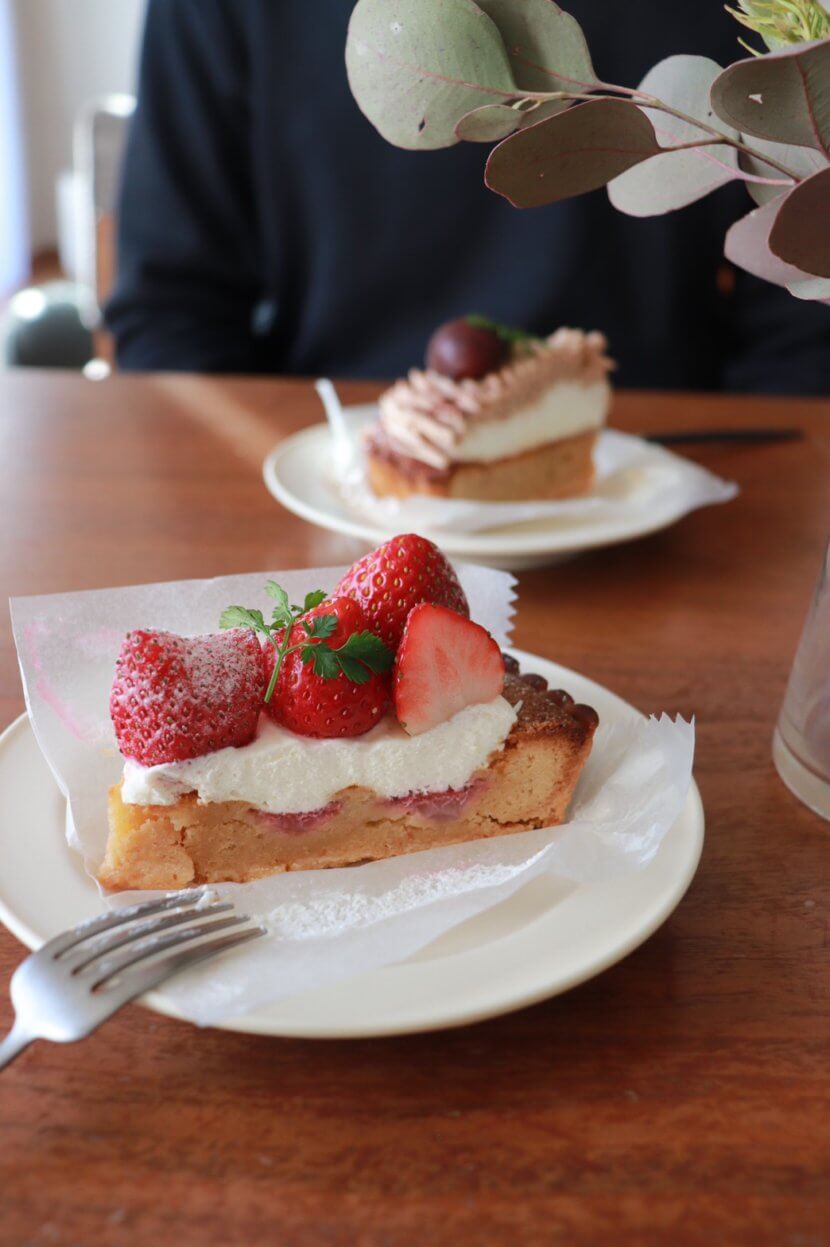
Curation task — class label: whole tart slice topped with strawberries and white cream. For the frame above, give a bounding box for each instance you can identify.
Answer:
[98,535,597,889]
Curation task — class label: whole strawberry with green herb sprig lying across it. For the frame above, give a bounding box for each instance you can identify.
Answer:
[265,597,391,737]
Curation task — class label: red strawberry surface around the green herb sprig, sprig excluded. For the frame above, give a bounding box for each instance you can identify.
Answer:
[265,597,391,737]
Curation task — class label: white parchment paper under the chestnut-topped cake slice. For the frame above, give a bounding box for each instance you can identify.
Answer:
[318,382,738,535]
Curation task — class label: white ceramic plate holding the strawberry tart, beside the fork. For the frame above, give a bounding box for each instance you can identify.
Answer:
[0,651,703,1039]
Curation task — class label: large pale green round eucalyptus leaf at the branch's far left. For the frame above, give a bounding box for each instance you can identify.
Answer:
[346,0,516,148]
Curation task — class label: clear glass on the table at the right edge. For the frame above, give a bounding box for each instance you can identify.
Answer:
[773,545,830,819]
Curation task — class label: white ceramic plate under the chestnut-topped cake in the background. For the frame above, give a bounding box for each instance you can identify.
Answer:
[263,405,707,571]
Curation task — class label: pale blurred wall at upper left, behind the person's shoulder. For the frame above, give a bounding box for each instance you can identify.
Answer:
[14,0,146,251]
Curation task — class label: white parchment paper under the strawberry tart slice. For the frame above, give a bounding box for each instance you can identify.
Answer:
[11,566,694,1025]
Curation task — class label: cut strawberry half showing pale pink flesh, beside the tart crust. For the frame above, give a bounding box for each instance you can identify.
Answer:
[393,602,505,736]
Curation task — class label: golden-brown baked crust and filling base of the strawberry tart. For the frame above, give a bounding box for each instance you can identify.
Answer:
[98,675,597,890]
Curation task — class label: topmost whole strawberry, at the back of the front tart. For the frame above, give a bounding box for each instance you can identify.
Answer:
[334,532,470,650]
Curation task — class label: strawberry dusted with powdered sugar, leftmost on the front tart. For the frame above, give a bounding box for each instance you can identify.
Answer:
[110,628,265,767]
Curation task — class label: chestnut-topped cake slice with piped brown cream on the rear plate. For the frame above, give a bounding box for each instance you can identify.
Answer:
[366,315,613,501]
